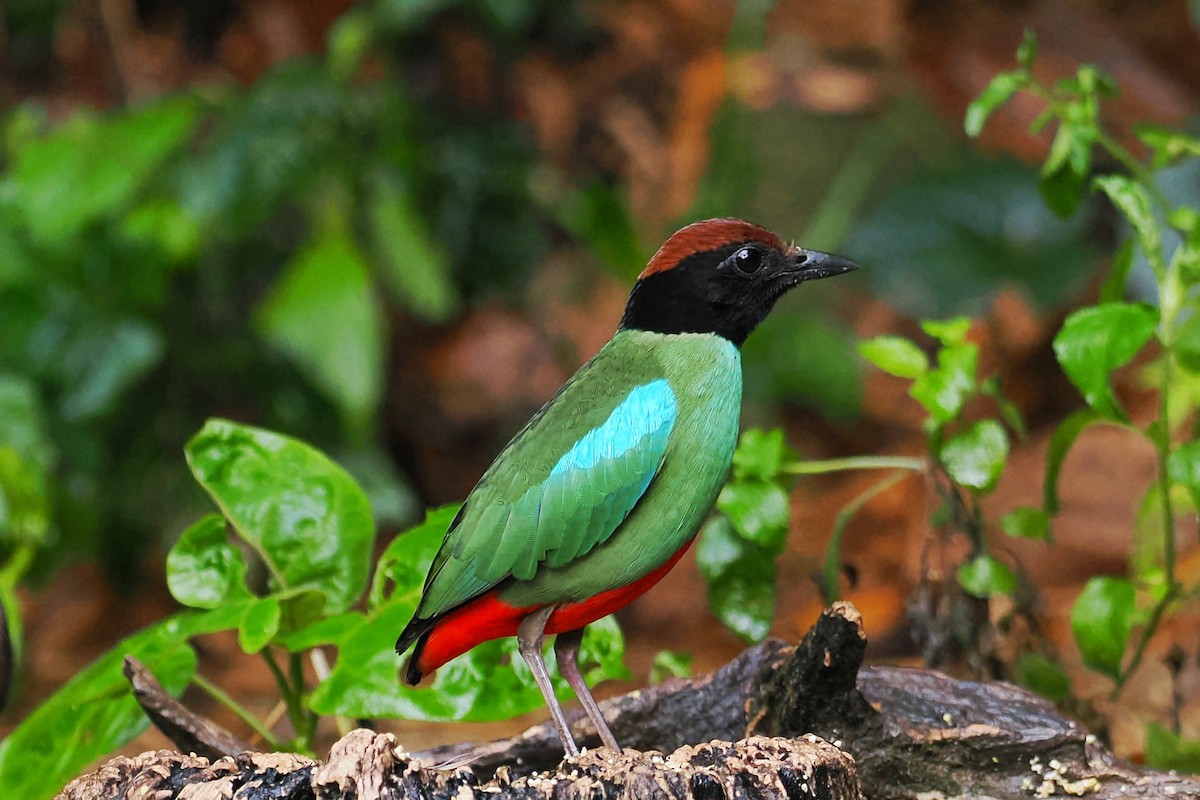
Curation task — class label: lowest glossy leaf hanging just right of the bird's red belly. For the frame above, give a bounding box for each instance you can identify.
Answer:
[696,517,776,644]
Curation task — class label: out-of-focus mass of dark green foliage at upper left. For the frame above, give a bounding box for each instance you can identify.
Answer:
[0,2,577,594]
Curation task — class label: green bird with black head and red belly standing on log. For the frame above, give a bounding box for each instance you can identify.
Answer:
[396,218,858,756]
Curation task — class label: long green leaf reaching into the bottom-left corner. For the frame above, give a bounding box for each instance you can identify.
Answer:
[0,609,240,800]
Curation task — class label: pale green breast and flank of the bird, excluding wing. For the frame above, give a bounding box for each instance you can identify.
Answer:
[500,331,742,606]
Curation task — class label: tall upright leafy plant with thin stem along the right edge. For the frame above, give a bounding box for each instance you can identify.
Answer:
[966,34,1200,710]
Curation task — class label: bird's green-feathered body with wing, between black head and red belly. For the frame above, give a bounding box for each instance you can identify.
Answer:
[416,331,740,619]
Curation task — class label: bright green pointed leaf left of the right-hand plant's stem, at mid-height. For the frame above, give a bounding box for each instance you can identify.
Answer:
[1054,302,1158,422]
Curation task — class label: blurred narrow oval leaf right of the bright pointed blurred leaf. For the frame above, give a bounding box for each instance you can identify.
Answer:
[367,175,458,321]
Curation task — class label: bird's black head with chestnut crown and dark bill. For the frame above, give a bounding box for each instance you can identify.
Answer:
[620,219,858,347]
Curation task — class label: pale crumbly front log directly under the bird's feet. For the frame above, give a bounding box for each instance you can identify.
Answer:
[59,729,862,800]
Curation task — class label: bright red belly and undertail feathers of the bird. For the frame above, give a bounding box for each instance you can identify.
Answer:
[416,541,691,675]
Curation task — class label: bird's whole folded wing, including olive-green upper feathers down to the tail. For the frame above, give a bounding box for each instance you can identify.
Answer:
[416,365,677,619]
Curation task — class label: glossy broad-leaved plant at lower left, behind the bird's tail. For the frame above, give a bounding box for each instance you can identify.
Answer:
[0,420,626,799]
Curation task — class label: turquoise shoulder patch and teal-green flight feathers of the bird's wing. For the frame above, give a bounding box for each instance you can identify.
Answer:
[458,379,678,584]
